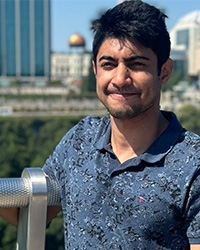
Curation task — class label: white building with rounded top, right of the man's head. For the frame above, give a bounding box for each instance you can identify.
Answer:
[170,11,200,79]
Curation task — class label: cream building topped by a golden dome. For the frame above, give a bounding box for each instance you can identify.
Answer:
[51,34,91,85]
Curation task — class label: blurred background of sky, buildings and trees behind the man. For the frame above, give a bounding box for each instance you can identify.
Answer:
[0,0,200,250]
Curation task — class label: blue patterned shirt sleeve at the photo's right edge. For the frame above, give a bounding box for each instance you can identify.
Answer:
[186,169,200,244]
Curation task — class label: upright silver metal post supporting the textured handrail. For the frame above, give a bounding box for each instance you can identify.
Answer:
[17,168,47,250]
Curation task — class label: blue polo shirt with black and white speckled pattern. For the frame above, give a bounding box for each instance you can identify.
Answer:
[44,112,200,250]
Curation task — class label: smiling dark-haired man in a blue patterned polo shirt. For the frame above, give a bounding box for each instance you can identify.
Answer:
[0,0,200,250]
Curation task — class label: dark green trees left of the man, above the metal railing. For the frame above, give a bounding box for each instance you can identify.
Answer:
[0,117,83,177]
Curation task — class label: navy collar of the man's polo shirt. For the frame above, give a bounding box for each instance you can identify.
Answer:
[94,111,183,163]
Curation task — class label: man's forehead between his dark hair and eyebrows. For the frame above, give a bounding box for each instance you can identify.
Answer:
[97,38,156,58]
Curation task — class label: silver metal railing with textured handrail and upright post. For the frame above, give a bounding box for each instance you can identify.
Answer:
[0,168,60,250]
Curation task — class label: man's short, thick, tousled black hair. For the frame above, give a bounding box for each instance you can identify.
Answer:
[91,0,170,74]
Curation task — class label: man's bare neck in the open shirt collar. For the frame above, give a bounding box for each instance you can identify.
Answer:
[111,111,168,163]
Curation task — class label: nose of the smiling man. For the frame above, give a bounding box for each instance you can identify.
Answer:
[112,64,132,88]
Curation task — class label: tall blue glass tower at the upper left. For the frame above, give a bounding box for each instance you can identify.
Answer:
[0,0,51,85]
